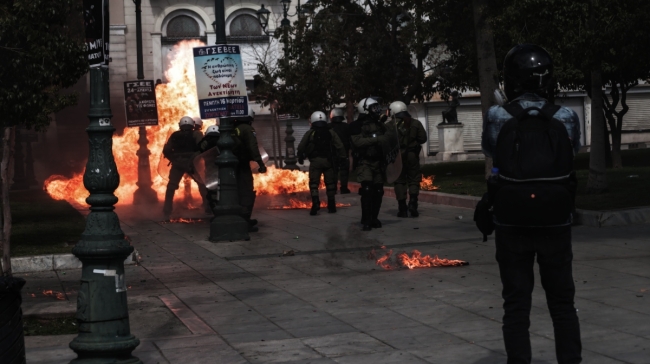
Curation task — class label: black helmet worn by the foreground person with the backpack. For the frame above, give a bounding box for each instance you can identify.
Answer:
[503,44,553,100]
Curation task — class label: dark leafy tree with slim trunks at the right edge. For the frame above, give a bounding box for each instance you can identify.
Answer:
[495,0,650,193]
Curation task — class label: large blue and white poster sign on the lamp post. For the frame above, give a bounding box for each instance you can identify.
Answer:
[193,44,248,119]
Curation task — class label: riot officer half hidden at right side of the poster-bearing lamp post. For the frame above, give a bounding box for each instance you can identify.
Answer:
[232,106,266,232]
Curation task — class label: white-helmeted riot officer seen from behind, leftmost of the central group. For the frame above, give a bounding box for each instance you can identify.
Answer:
[298,111,347,216]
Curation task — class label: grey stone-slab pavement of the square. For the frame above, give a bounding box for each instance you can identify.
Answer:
[22,195,650,364]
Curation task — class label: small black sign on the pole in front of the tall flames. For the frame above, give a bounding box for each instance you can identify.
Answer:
[124,80,158,127]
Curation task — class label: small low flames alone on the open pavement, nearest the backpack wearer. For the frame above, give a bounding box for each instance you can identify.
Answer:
[368,246,469,270]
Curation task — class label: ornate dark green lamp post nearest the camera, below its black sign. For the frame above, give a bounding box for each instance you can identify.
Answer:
[70,66,142,364]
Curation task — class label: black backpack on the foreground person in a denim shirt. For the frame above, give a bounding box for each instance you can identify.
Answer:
[488,102,576,227]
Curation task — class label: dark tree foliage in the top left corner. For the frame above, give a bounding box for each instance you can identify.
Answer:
[0,0,88,129]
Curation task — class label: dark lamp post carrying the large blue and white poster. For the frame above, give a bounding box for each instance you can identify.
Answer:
[210,0,250,242]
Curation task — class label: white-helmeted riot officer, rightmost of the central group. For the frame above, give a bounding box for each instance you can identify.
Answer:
[388,101,427,217]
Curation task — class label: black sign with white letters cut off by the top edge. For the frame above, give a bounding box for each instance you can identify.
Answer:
[83,0,109,67]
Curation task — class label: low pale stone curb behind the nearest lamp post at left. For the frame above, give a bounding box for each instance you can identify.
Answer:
[11,250,138,273]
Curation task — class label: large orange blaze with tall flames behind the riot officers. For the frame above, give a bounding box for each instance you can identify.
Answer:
[43,40,316,205]
